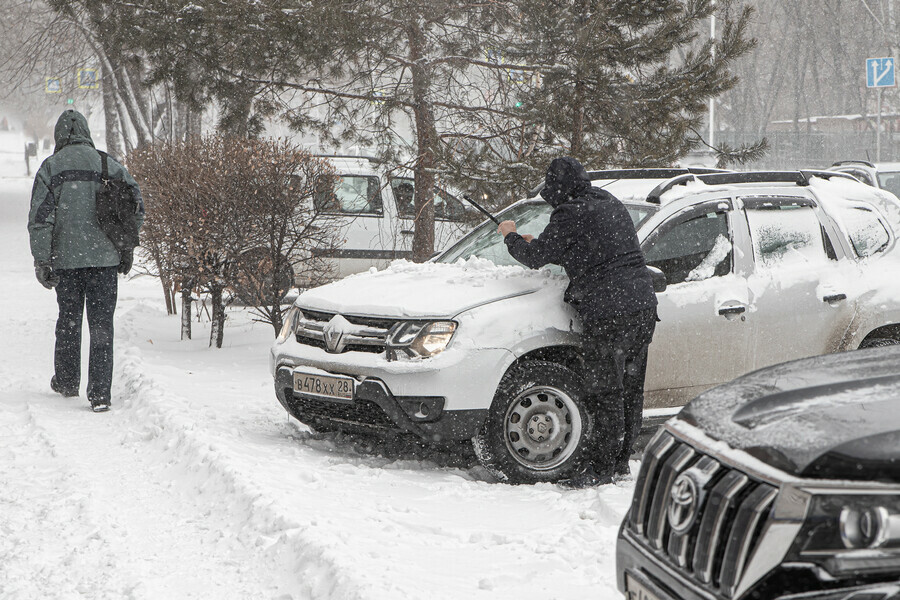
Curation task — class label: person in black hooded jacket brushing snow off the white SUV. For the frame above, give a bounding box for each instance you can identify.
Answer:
[497,157,658,487]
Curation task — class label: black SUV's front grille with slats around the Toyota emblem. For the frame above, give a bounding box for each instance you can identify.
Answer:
[626,432,778,598]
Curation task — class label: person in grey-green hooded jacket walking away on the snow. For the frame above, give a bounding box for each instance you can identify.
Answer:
[28,109,144,412]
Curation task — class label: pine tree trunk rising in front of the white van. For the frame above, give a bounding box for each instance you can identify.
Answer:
[408,23,438,262]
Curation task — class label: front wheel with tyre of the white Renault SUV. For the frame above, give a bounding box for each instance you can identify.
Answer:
[472,360,591,483]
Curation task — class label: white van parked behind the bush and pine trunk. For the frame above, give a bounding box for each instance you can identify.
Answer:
[308,156,470,283]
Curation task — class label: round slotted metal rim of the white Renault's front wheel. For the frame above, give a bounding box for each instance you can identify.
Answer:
[503,386,582,471]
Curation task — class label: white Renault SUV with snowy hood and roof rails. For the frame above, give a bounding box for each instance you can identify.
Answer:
[271,170,900,482]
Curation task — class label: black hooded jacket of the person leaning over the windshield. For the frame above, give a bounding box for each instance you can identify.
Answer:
[505,157,656,320]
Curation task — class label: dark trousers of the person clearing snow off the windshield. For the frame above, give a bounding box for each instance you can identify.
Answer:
[582,309,656,474]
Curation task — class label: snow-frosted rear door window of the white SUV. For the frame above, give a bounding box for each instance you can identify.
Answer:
[747,204,827,268]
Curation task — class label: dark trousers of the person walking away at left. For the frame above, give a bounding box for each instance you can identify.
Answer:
[54,267,118,403]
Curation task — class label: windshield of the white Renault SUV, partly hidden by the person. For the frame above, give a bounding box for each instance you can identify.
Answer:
[436,201,657,266]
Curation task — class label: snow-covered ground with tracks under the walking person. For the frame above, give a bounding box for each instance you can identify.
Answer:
[0,152,637,600]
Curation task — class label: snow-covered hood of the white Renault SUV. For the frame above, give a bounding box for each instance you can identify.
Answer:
[296,258,567,319]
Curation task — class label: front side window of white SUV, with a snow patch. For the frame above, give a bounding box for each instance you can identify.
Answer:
[644,210,731,284]
